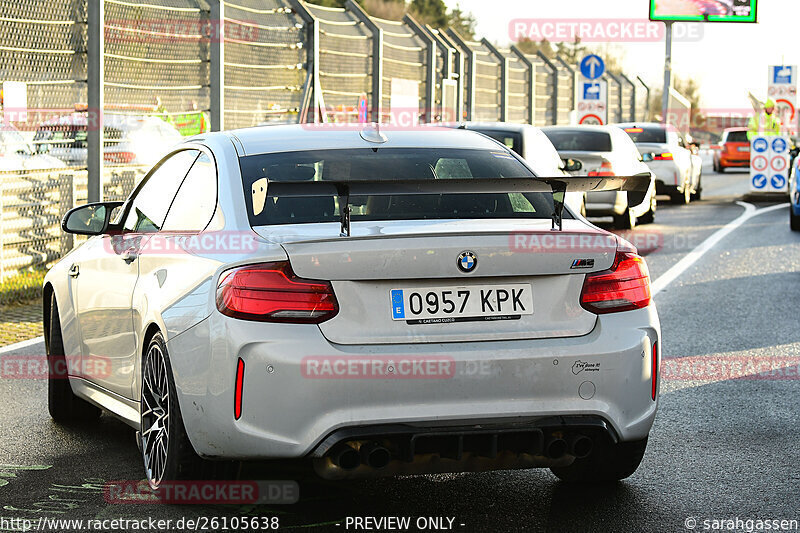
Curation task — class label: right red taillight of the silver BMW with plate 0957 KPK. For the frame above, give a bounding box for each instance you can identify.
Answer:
[581,250,650,315]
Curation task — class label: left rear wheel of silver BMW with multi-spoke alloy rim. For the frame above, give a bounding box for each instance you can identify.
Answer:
[137,333,238,490]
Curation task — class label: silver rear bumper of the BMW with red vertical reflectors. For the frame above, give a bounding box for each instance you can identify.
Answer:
[168,304,660,460]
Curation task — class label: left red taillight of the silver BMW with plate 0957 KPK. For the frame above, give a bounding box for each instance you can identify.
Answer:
[217,261,339,324]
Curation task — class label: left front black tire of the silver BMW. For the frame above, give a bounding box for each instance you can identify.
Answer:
[46,294,102,424]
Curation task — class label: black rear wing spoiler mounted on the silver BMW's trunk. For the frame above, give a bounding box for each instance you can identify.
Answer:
[267,173,651,237]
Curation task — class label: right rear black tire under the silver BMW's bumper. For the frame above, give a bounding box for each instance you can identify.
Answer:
[550,438,647,484]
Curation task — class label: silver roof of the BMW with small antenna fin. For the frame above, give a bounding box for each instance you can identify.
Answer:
[223,124,507,155]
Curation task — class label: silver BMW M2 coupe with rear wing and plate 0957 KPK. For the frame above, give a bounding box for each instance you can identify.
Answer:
[44,125,661,488]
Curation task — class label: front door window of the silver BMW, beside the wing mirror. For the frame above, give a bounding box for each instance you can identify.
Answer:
[123,150,200,233]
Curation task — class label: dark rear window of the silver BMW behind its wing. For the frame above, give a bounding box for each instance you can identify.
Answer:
[239,148,569,226]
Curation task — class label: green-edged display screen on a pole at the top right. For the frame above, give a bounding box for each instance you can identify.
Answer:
[650,0,758,22]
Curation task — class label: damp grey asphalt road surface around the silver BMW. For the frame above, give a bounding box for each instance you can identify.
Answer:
[0,158,800,532]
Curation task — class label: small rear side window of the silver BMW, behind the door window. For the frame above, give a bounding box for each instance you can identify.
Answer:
[161,154,217,233]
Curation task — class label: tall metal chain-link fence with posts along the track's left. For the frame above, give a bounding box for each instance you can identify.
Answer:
[0,0,649,286]
